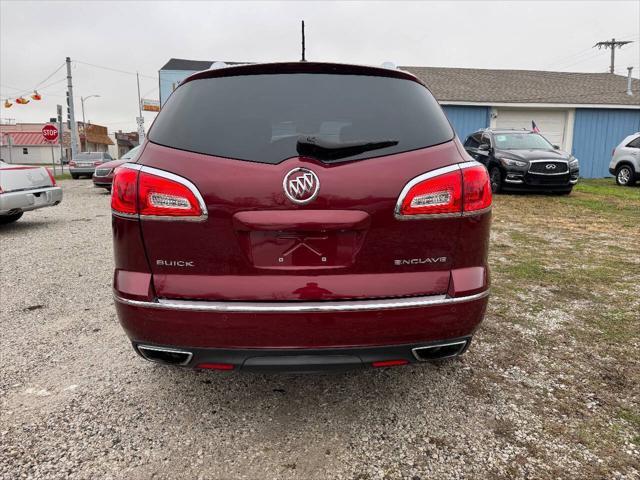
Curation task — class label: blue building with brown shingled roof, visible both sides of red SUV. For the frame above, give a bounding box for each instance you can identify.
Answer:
[159,58,640,178]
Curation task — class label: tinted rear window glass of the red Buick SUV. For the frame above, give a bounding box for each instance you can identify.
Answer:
[149,73,454,164]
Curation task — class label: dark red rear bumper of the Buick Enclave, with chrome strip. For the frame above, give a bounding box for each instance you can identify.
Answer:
[115,290,488,366]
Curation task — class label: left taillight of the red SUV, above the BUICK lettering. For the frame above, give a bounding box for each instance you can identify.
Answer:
[111,166,206,220]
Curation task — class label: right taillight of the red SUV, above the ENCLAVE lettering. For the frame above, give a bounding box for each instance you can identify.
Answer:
[396,162,491,220]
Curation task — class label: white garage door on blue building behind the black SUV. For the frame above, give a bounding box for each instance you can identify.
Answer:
[496,108,567,148]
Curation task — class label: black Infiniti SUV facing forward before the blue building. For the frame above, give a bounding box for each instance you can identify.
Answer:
[464,128,580,195]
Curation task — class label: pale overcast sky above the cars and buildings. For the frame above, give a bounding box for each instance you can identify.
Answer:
[0,0,640,132]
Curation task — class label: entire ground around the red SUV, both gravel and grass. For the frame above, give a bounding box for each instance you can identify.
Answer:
[0,180,640,480]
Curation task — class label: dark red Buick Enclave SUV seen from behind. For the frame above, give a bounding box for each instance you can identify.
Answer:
[111,62,491,371]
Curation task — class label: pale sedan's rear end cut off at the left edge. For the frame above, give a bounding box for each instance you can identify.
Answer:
[0,160,62,225]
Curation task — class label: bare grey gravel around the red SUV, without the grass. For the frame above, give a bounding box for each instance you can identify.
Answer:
[0,180,640,480]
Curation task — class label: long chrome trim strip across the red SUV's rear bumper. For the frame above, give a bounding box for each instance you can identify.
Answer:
[114,290,489,313]
